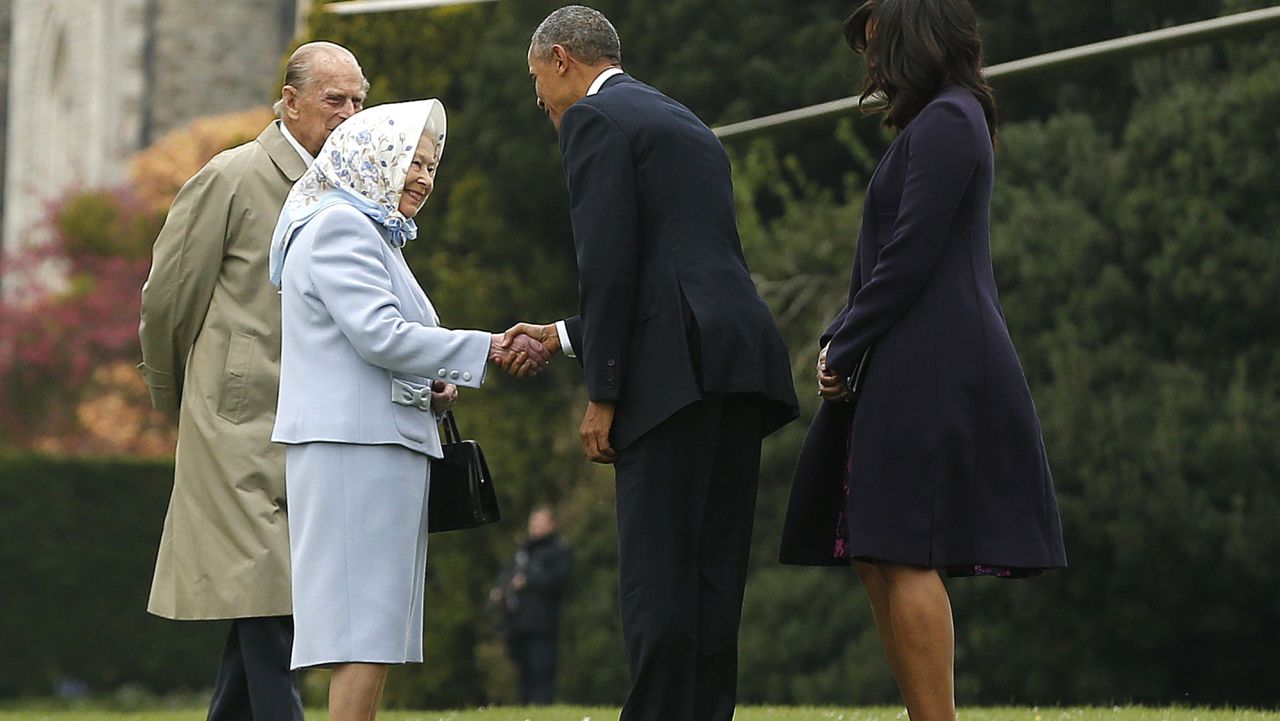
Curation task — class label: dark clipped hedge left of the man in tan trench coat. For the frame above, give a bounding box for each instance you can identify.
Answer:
[0,453,225,697]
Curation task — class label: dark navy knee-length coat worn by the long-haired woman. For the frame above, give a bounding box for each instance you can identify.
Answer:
[781,86,1066,569]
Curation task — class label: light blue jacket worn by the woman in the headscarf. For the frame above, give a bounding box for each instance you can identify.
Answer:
[271,205,490,457]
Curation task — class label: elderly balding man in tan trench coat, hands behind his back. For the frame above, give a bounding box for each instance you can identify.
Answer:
[138,42,369,721]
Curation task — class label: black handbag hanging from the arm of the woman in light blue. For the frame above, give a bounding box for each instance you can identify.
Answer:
[426,411,502,533]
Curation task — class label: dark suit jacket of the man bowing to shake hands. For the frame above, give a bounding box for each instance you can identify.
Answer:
[559,74,797,450]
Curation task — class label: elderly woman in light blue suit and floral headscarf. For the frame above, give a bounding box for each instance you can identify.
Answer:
[270,100,545,721]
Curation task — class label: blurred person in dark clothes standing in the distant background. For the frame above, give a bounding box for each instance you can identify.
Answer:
[489,506,573,704]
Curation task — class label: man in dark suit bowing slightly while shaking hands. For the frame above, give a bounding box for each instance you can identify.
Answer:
[508,5,797,721]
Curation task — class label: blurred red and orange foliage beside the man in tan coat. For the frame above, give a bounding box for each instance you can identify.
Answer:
[0,109,270,457]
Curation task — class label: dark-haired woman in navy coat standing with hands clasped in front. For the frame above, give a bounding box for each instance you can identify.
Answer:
[781,0,1066,721]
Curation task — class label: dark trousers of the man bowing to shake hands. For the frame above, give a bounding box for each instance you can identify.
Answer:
[617,396,760,721]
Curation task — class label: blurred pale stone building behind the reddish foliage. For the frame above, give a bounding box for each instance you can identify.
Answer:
[0,0,308,259]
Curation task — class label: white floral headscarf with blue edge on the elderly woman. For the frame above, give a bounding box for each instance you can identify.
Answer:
[269,99,445,288]
